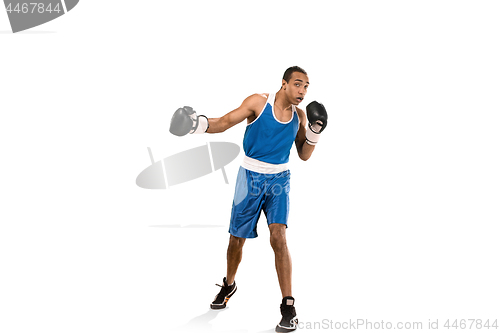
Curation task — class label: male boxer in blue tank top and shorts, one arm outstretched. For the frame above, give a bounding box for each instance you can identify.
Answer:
[170,66,327,332]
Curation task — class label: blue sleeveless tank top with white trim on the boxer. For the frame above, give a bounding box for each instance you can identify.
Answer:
[243,94,299,164]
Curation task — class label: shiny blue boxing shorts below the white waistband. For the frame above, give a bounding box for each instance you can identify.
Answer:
[229,166,290,238]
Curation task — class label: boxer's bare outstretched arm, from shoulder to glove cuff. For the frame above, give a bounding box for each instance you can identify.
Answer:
[207,94,266,133]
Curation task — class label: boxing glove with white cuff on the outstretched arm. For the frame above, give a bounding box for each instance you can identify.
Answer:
[170,106,208,136]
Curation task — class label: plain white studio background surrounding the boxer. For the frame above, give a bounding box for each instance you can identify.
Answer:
[0,0,500,333]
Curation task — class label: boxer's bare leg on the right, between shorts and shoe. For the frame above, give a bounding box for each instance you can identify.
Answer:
[269,223,292,297]
